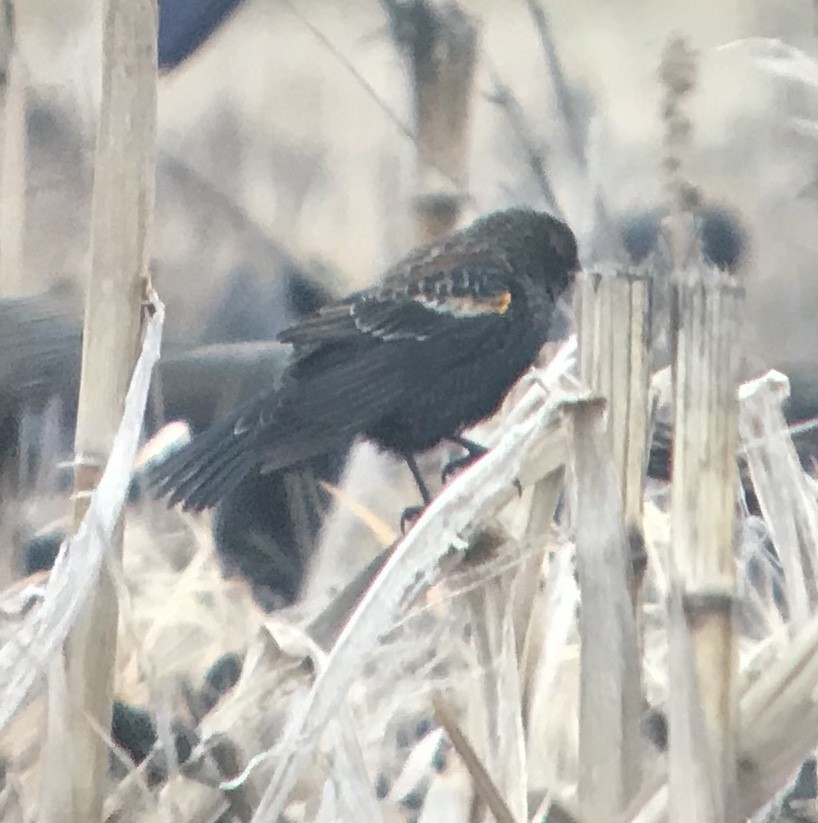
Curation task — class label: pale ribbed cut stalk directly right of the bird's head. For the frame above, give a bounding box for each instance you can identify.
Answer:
[576,273,652,613]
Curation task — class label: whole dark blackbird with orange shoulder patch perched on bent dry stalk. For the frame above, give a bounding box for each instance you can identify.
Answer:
[148,209,579,510]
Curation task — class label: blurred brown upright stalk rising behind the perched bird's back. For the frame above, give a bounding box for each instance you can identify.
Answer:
[385,0,477,243]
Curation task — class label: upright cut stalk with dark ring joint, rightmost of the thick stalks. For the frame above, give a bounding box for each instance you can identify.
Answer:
[668,265,743,823]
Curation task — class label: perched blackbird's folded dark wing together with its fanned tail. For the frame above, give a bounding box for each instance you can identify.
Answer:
[154,261,515,509]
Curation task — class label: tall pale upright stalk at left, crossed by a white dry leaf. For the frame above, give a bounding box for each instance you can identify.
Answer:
[41,0,157,823]
